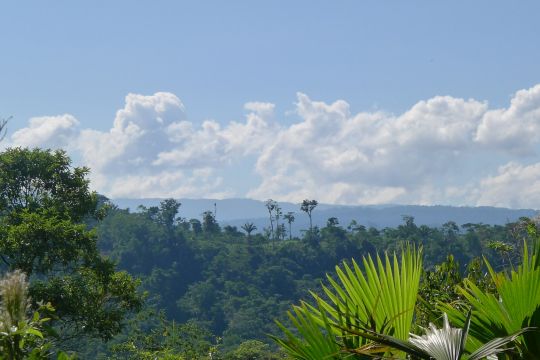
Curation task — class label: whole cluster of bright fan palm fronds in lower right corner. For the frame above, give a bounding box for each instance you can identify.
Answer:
[272,222,540,360]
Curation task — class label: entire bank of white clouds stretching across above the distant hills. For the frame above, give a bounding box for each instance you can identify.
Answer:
[4,85,540,208]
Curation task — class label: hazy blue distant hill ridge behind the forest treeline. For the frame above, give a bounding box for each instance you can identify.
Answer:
[111,198,539,234]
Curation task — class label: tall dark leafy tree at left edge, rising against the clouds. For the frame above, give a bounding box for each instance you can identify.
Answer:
[0,148,142,339]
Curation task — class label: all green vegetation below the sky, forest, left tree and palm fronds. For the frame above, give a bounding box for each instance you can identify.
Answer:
[0,148,540,360]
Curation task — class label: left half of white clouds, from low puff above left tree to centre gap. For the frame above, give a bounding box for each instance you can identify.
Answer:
[6,92,276,197]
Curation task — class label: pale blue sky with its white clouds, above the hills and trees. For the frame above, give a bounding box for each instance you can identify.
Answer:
[0,0,540,209]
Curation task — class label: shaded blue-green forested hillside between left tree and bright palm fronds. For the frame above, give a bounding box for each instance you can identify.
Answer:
[89,199,524,354]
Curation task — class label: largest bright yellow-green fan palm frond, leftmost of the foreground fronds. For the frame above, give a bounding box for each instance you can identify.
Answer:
[273,247,422,360]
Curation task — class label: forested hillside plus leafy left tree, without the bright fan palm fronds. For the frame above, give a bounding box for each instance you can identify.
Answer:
[0,149,536,360]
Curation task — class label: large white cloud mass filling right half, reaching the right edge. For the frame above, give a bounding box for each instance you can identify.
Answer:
[249,85,540,207]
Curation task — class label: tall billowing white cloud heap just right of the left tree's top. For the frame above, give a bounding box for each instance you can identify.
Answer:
[74,93,264,197]
